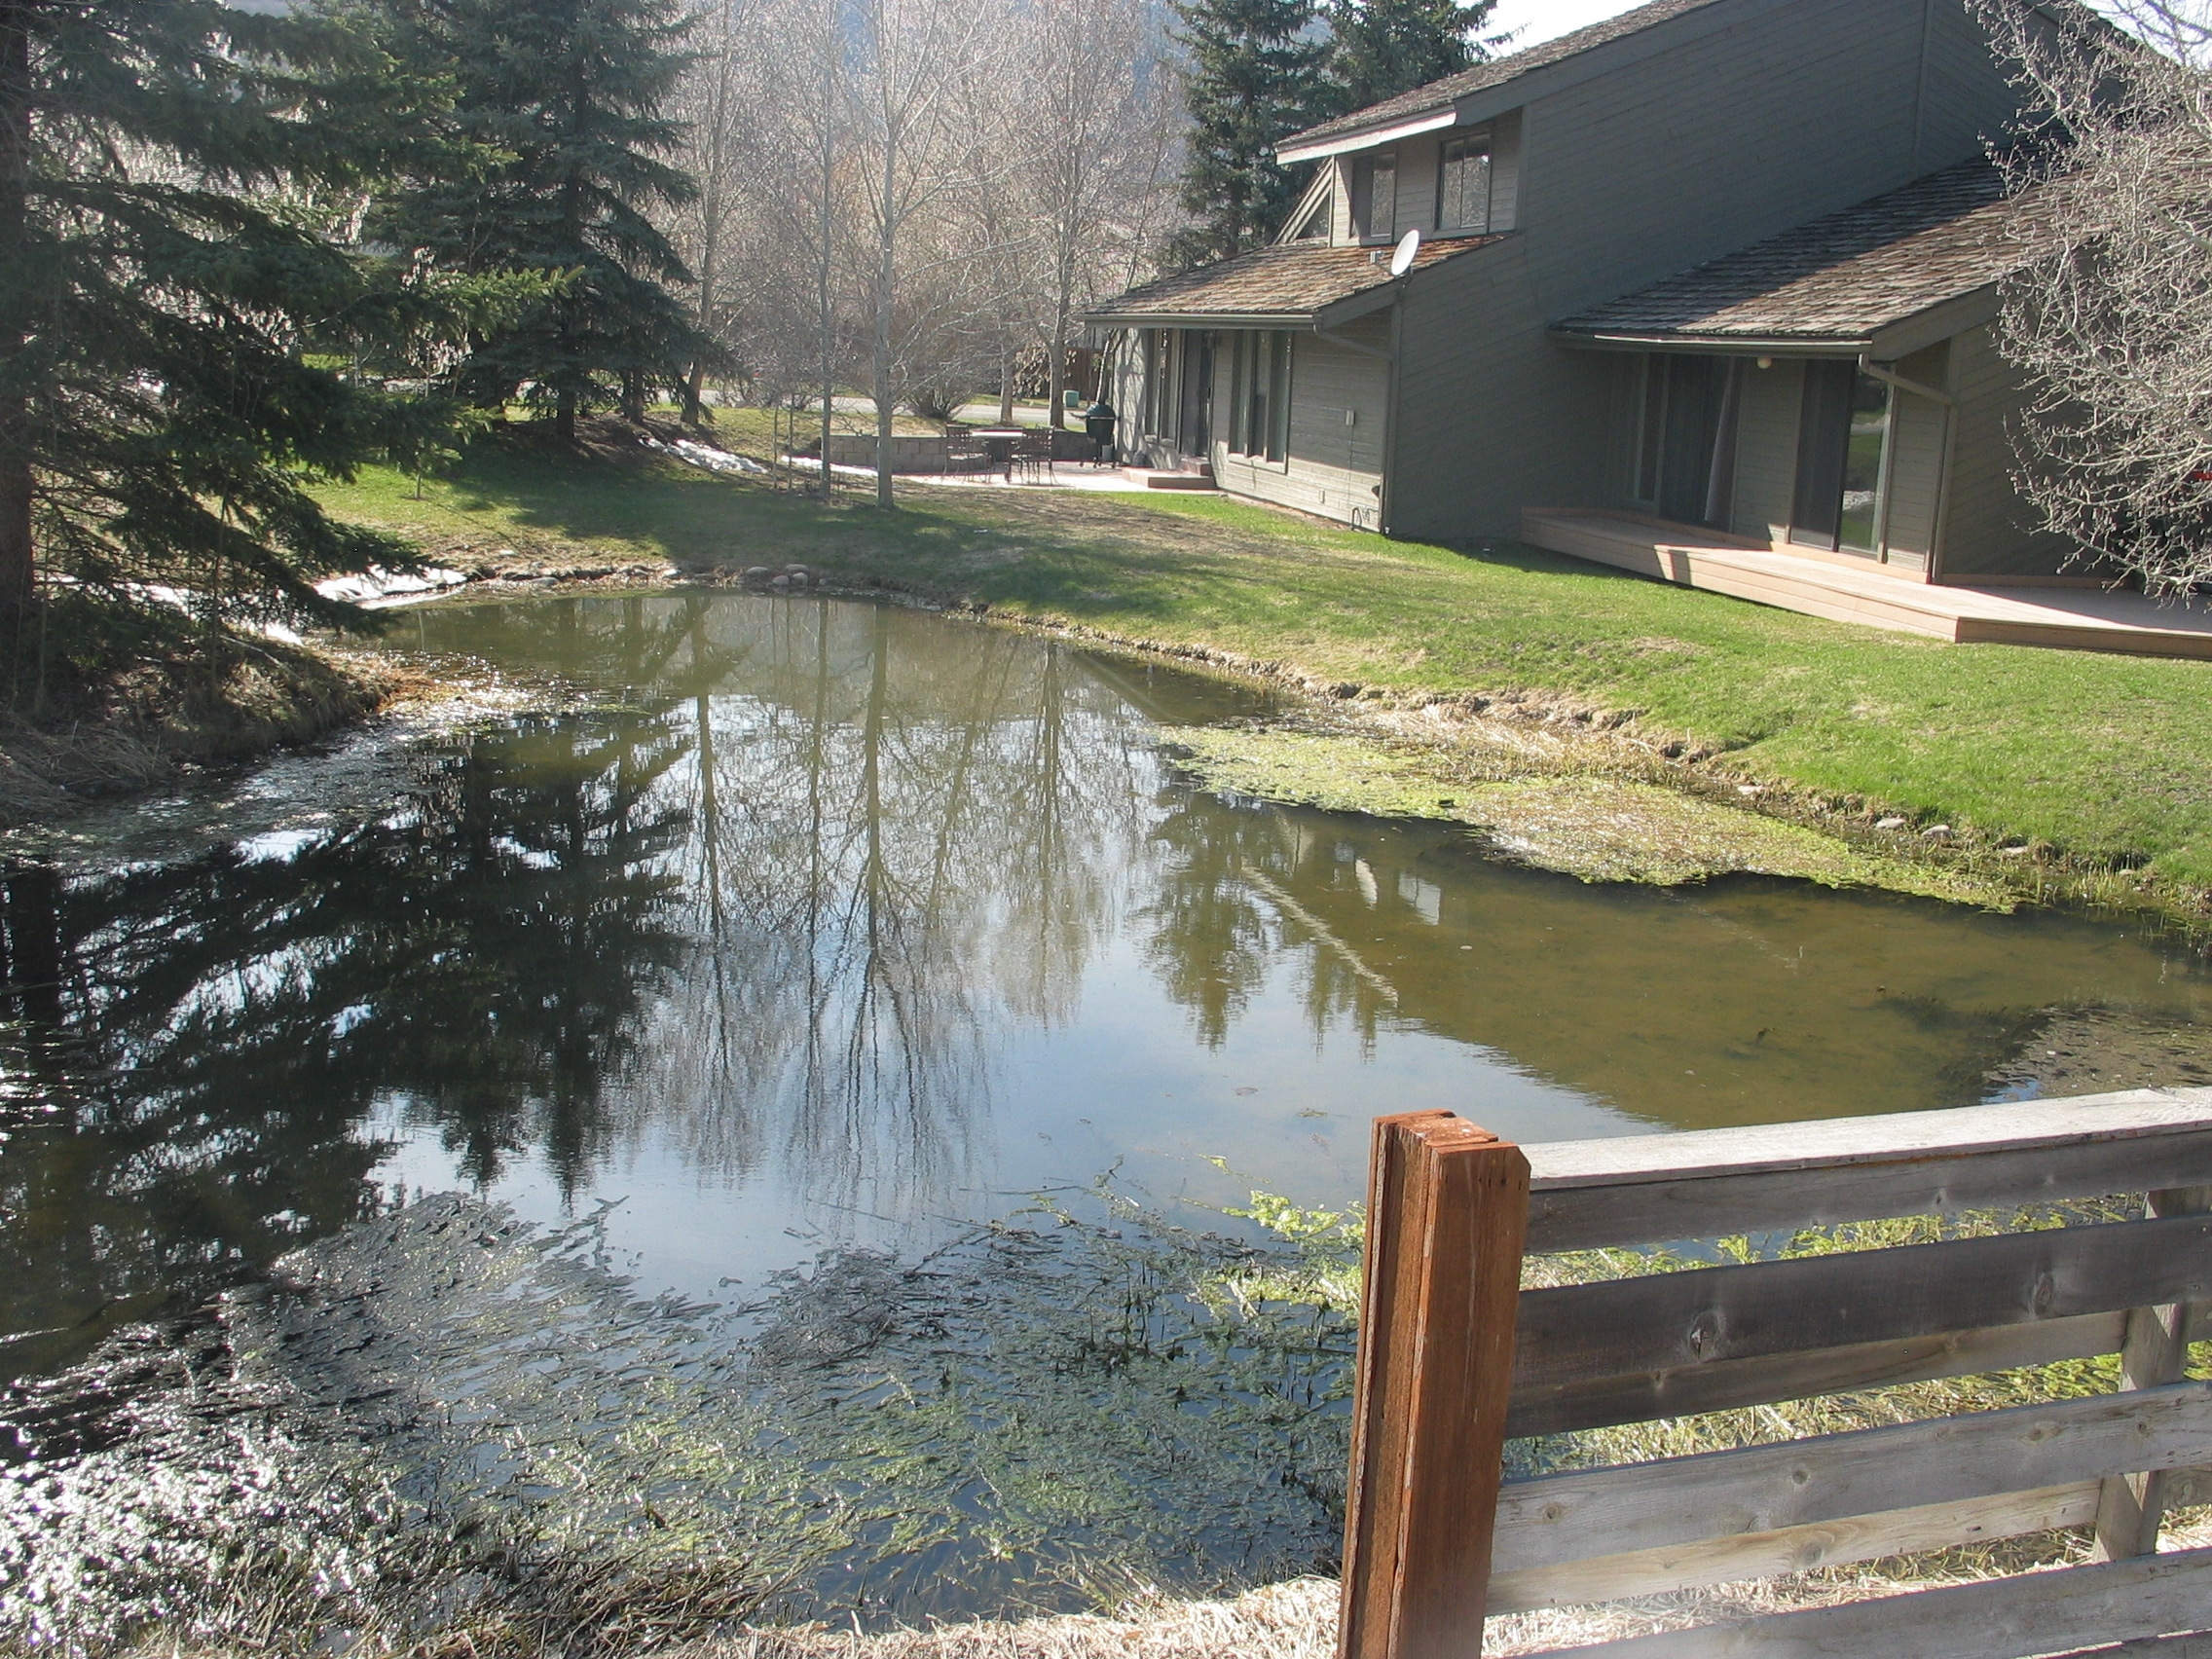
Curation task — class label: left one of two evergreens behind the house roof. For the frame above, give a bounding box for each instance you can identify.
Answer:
[1165,0,1329,270]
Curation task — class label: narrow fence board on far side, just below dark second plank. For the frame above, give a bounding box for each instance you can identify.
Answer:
[1506,1311,2128,1438]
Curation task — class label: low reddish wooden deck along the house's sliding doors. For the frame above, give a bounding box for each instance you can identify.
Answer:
[1522,506,2212,657]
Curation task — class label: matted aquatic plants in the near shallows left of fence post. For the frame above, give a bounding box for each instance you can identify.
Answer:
[0,1195,1351,1652]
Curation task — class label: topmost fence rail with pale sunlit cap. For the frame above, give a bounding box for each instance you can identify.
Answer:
[1529,1088,2212,1252]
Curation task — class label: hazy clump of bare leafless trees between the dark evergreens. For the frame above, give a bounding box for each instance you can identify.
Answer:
[663,0,1184,502]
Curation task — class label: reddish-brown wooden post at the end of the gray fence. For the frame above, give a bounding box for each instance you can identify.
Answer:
[1336,1113,1529,1659]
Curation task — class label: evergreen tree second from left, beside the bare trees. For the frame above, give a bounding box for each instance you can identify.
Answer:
[374,0,706,438]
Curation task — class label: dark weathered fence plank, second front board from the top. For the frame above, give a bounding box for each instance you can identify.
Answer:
[1513,1217,2212,1389]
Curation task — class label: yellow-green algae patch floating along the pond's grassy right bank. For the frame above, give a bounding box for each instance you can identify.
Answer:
[1161,725,2010,909]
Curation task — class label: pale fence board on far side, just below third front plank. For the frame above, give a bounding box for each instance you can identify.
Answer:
[1489,1480,2104,1612]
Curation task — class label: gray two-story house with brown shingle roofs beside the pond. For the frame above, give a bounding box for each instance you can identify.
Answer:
[1090,0,2064,582]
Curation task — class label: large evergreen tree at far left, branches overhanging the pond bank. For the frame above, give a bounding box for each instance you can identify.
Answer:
[0,0,504,677]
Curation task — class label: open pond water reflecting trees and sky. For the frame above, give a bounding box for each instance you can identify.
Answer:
[0,593,2212,1374]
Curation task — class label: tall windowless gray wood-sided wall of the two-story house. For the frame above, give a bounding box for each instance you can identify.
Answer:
[1389,0,2013,539]
